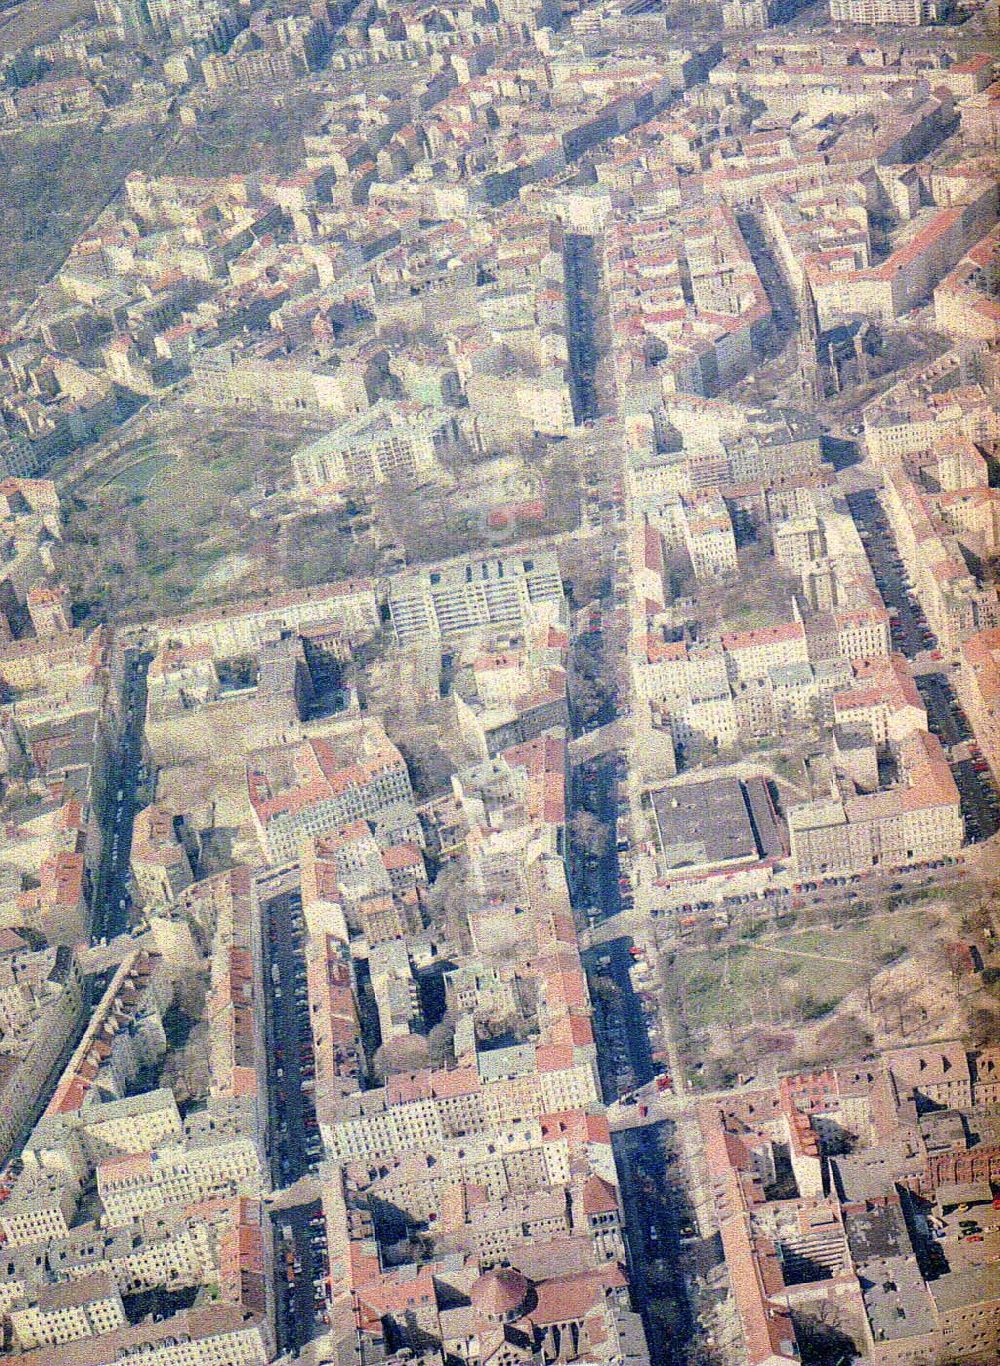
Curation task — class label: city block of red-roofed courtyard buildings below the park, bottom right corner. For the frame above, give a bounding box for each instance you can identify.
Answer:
[698,1044,1000,1366]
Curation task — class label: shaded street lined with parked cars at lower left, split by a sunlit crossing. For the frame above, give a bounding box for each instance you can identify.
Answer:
[262,891,329,1352]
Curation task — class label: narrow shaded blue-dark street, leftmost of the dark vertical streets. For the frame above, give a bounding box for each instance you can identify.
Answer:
[90,650,149,943]
